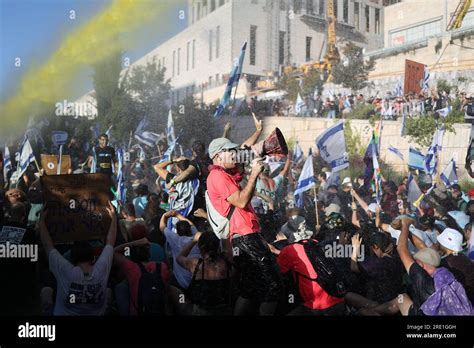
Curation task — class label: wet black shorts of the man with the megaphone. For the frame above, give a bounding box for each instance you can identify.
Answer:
[232,233,282,303]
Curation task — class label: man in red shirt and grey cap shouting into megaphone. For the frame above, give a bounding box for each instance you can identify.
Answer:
[207,115,288,315]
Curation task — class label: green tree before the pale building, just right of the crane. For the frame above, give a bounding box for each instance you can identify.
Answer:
[332,42,375,92]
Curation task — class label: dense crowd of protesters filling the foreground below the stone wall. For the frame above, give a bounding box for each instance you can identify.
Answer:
[0,113,474,316]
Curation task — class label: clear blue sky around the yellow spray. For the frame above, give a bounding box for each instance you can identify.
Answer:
[0,0,187,102]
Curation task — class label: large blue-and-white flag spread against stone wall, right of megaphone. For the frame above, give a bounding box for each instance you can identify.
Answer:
[316,121,349,172]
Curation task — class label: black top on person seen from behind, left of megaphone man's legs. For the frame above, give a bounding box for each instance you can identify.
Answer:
[188,259,231,315]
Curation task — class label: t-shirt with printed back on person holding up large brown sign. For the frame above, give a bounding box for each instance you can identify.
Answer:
[49,245,114,315]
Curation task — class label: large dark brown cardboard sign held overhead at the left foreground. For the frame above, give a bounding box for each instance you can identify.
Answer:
[41,173,112,244]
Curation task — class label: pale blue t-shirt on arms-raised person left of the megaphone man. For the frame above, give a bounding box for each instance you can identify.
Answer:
[163,226,201,289]
